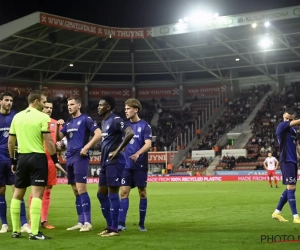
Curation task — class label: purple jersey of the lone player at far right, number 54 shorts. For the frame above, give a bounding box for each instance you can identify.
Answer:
[276,121,297,163]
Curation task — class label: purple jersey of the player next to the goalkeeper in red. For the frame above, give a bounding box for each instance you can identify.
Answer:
[60,114,98,159]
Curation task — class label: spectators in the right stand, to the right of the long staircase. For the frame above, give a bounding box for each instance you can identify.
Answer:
[214,83,300,169]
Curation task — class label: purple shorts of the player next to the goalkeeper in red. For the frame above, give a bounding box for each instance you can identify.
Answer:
[66,155,90,184]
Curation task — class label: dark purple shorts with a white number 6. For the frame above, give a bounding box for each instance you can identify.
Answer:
[121,168,148,188]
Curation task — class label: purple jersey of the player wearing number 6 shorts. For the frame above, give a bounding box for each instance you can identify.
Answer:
[125,120,152,171]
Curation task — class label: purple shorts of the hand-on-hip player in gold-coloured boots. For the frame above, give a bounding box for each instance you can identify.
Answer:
[99,162,125,187]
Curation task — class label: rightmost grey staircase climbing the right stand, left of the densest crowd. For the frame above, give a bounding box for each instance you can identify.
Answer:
[206,90,273,175]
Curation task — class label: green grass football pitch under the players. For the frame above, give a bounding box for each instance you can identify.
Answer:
[0,182,300,250]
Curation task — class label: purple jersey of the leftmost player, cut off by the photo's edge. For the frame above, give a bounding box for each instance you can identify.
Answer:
[0,110,16,161]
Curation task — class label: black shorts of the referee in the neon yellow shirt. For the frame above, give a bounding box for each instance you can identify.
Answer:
[15,153,48,188]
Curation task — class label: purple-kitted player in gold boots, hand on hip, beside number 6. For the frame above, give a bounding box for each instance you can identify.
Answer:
[97,96,134,237]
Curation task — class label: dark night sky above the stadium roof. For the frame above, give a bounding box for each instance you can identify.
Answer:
[0,0,300,27]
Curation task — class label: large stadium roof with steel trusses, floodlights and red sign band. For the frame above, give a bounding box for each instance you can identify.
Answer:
[0,6,300,84]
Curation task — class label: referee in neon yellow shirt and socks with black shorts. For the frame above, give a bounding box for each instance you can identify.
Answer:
[8,90,65,240]
